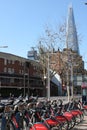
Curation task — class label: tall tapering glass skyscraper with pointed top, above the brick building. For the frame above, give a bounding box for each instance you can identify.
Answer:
[66,5,79,55]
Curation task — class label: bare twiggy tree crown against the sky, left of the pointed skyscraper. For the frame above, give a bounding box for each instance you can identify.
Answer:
[37,22,66,78]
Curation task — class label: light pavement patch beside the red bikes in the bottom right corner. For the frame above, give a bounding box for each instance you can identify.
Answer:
[72,116,87,130]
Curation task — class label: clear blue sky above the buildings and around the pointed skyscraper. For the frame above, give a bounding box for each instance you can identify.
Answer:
[0,0,87,66]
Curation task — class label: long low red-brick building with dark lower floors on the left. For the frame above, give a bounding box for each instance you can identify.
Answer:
[0,52,58,97]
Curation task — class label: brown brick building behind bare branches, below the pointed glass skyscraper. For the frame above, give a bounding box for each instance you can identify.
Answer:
[51,49,86,93]
